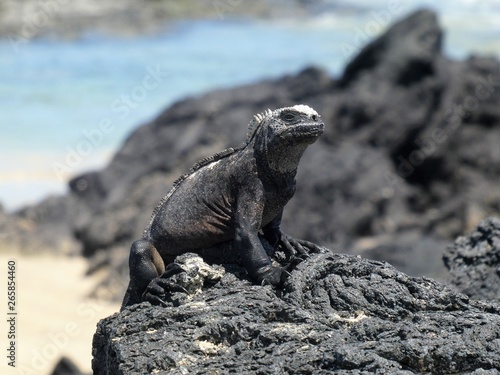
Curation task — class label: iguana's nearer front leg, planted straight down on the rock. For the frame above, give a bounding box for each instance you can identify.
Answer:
[234,181,287,286]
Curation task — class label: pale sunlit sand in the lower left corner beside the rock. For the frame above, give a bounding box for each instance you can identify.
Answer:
[0,254,119,375]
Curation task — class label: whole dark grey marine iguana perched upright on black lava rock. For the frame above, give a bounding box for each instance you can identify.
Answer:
[122,104,324,309]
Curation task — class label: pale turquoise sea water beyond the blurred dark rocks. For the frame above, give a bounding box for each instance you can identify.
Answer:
[0,0,500,210]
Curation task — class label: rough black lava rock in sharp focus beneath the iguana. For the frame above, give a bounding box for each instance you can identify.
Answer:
[92,249,500,375]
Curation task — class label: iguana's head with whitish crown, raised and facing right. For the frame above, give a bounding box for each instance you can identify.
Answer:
[247,104,325,174]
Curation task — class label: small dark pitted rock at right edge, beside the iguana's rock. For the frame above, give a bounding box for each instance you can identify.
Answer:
[443,217,500,302]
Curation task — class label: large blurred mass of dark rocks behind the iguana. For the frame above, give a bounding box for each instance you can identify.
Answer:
[0,10,500,290]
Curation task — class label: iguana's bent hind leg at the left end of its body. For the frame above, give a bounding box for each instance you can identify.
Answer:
[122,239,165,310]
